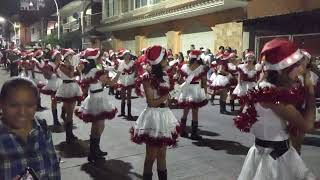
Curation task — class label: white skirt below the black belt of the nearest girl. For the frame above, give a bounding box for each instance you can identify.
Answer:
[238,145,316,180]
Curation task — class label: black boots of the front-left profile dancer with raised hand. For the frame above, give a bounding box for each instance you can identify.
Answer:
[88,136,108,163]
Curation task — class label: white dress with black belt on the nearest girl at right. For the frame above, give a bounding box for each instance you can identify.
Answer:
[235,83,316,180]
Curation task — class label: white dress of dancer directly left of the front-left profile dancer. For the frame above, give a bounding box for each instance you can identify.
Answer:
[56,65,82,102]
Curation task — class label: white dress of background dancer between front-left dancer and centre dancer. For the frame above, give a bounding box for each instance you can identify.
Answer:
[115,60,135,89]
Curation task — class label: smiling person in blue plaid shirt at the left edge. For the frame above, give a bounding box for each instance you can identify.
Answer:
[0,78,61,180]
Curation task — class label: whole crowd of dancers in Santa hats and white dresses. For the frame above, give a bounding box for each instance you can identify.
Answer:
[1,38,319,180]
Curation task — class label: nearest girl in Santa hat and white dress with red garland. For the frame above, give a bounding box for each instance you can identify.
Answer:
[234,39,316,180]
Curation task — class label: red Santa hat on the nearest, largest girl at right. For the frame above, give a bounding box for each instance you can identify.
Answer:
[261,38,304,71]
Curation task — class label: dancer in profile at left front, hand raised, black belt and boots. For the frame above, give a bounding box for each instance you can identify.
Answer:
[75,48,120,163]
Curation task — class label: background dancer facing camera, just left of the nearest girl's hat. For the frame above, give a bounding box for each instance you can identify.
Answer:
[233,52,258,111]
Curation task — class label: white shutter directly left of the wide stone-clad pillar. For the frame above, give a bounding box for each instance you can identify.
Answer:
[180,31,214,56]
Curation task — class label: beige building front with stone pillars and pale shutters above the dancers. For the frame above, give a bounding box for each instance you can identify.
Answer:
[99,0,248,54]
